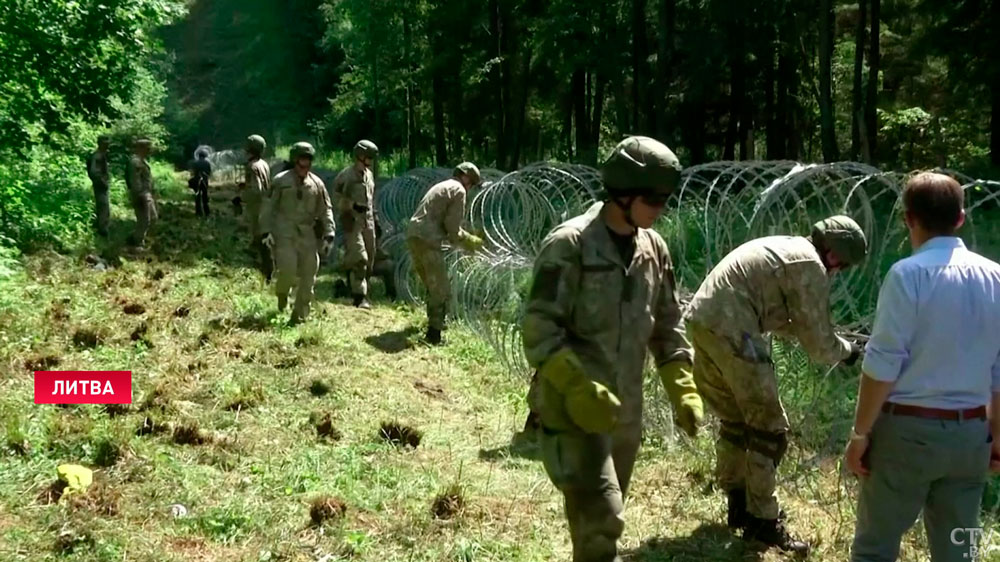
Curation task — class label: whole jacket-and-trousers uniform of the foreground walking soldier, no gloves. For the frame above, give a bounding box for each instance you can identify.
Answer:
[522,203,692,561]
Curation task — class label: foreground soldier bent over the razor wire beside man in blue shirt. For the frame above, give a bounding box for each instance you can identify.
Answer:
[687,216,866,553]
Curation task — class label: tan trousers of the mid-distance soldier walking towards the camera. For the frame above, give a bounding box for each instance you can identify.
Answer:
[274,235,319,321]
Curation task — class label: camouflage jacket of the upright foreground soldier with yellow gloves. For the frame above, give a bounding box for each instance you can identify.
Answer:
[522,203,692,428]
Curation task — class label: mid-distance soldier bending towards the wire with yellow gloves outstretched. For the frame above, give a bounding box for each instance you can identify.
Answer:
[406,162,483,345]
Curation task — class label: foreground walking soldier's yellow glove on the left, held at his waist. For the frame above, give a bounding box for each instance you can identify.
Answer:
[538,349,621,433]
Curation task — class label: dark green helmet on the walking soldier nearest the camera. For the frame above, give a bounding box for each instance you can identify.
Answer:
[601,136,681,196]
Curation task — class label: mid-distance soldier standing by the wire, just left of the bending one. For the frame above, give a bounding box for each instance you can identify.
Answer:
[333,140,378,309]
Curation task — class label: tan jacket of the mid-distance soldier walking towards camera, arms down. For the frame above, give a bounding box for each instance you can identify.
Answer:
[260,169,336,242]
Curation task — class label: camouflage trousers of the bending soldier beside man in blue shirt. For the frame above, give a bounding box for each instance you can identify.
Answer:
[688,324,788,519]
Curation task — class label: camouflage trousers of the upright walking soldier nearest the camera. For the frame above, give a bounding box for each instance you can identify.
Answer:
[539,426,641,562]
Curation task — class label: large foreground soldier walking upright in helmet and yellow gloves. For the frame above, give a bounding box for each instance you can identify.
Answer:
[522,137,702,562]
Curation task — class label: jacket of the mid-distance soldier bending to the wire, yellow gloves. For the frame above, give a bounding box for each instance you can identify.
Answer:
[406,179,465,245]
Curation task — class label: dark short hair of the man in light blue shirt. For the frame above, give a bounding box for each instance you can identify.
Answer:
[903,172,965,234]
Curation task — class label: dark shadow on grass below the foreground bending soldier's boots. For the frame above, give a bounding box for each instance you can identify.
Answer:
[624,523,763,562]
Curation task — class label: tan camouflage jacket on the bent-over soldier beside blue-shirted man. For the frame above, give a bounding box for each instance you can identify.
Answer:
[687,236,851,364]
